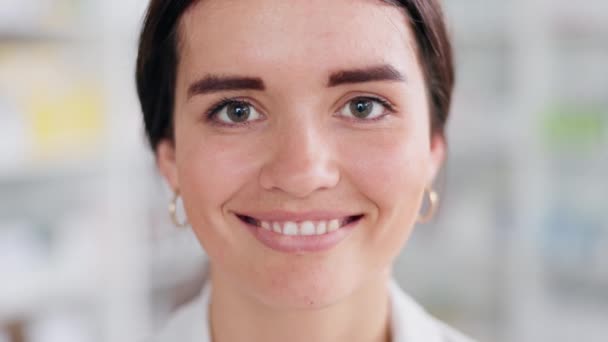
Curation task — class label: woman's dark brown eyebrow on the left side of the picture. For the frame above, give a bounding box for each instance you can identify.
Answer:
[188,75,265,98]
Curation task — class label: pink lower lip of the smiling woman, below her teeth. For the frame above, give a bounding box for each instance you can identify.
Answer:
[239,218,363,254]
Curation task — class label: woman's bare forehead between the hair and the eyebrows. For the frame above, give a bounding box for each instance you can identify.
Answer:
[179,0,415,85]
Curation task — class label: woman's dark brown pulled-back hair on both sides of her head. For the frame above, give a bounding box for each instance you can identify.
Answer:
[136,0,454,149]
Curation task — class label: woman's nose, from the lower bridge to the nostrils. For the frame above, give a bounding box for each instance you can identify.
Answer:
[260,120,340,198]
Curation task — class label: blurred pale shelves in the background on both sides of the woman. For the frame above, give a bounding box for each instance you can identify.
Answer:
[0,0,608,342]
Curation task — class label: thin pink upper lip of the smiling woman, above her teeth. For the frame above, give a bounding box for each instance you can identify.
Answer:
[235,210,363,222]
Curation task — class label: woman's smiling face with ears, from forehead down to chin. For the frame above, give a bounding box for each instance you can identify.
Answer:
[157,0,444,308]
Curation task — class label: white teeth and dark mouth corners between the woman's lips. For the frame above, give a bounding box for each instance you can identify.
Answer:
[236,214,364,236]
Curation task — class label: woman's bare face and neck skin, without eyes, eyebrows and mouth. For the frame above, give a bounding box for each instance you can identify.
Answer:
[157,0,445,342]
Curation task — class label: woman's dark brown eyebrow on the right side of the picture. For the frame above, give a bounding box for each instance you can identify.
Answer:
[327,64,405,87]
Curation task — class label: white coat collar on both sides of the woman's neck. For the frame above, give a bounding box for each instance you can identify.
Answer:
[146,268,473,342]
